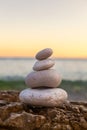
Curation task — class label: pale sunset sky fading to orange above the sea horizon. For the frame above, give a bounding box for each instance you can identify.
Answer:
[0,0,87,58]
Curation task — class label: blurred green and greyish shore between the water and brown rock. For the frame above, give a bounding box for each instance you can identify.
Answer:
[0,80,87,101]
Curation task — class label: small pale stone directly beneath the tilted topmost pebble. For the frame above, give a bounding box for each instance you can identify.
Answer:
[33,59,55,71]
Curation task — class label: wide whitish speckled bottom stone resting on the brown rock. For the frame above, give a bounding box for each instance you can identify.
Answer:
[19,88,68,107]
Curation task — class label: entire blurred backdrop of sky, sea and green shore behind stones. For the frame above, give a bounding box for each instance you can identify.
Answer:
[0,0,87,101]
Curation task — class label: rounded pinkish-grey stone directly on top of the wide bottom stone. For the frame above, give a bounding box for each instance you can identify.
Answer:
[25,69,61,88]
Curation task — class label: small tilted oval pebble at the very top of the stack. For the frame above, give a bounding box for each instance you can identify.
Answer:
[35,48,53,60]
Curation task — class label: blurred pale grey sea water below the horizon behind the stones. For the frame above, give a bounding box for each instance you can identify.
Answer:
[0,58,87,80]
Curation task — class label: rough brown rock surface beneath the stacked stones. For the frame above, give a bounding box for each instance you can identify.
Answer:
[0,91,87,130]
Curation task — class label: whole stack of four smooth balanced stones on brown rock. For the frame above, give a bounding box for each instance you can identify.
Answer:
[19,48,68,107]
